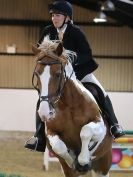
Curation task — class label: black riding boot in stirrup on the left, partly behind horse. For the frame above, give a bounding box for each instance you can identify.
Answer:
[25,101,46,152]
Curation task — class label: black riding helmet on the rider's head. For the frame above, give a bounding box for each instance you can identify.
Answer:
[48,0,72,20]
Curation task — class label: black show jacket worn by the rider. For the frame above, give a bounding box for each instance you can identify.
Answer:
[39,23,98,80]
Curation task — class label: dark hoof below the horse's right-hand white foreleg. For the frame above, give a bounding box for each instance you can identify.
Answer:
[75,160,92,172]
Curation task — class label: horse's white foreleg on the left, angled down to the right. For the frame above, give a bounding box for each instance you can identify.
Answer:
[47,135,74,168]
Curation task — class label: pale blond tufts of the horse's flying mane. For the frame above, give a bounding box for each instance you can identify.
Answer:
[38,36,76,63]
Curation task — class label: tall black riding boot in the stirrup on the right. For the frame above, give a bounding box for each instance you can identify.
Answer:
[105,96,125,139]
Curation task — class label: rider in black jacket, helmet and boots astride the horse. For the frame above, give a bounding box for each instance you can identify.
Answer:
[25,1,124,152]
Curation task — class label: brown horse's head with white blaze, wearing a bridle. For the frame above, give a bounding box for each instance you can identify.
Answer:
[32,38,75,120]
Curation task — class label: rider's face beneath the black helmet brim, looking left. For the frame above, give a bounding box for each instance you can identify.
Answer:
[52,13,65,28]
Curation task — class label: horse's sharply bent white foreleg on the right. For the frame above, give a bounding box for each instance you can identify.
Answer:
[78,120,106,170]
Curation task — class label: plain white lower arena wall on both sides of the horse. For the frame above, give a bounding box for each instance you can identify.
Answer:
[0,89,133,131]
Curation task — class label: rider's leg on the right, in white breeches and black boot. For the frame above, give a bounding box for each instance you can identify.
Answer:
[81,73,124,138]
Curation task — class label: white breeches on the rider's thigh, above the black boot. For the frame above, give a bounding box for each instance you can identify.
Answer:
[81,73,107,97]
